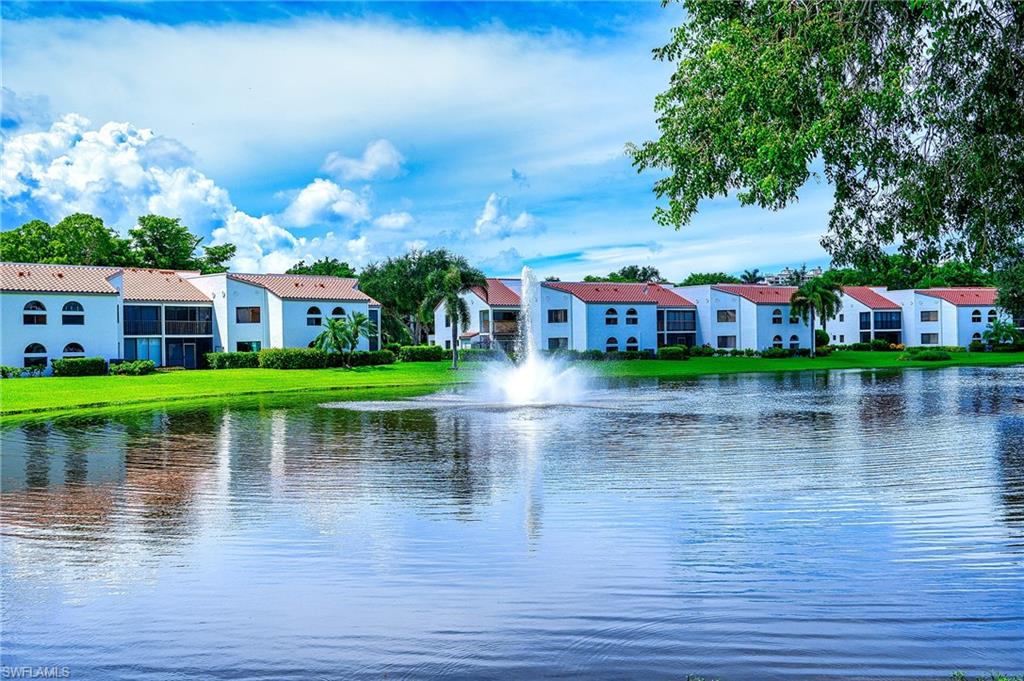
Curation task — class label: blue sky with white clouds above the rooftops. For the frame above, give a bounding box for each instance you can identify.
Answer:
[0,2,831,280]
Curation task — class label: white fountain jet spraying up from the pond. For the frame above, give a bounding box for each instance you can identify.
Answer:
[484,267,586,406]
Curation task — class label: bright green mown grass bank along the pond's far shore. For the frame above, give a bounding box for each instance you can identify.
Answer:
[0,351,1024,419]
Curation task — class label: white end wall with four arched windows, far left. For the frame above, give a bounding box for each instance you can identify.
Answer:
[0,288,122,367]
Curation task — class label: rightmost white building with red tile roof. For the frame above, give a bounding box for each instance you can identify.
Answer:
[886,287,1014,347]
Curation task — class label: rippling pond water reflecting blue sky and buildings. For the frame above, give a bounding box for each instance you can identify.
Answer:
[0,369,1024,679]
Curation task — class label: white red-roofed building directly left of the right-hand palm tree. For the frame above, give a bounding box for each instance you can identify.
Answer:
[673,284,811,350]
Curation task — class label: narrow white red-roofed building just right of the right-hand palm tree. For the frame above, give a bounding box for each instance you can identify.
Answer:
[816,286,904,345]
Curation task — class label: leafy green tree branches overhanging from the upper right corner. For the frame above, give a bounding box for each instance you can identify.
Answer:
[629,0,1024,265]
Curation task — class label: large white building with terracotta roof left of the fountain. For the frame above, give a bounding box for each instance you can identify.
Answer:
[0,262,380,369]
